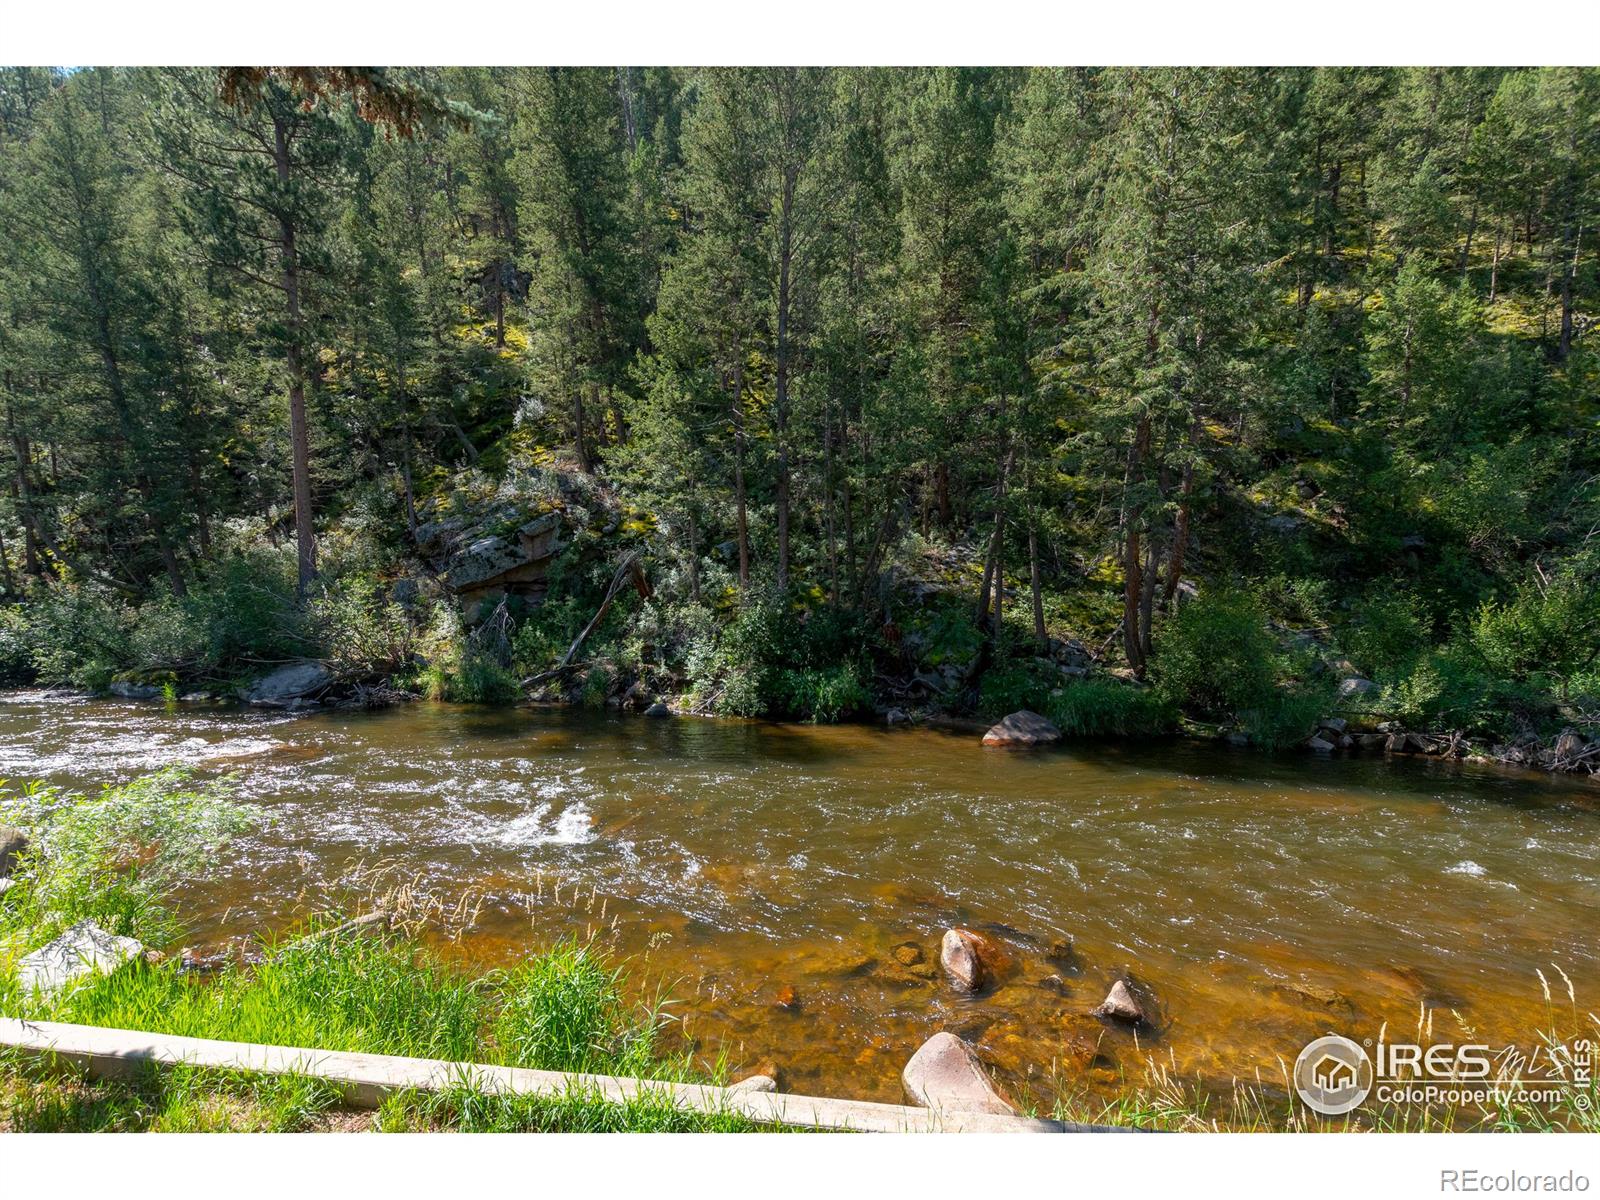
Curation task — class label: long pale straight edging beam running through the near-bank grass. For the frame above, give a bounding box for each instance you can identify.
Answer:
[0,1018,1120,1133]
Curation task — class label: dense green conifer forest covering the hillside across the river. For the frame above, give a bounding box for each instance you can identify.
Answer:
[0,67,1600,763]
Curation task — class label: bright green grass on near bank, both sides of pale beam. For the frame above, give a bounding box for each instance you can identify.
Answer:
[0,933,777,1131]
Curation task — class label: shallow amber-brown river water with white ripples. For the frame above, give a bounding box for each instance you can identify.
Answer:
[0,693,1600,1107]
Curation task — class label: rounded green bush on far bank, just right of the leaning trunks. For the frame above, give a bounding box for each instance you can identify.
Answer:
[1150,589,1278,720]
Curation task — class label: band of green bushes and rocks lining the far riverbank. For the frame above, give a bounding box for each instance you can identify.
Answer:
[0,466,1600,774]
